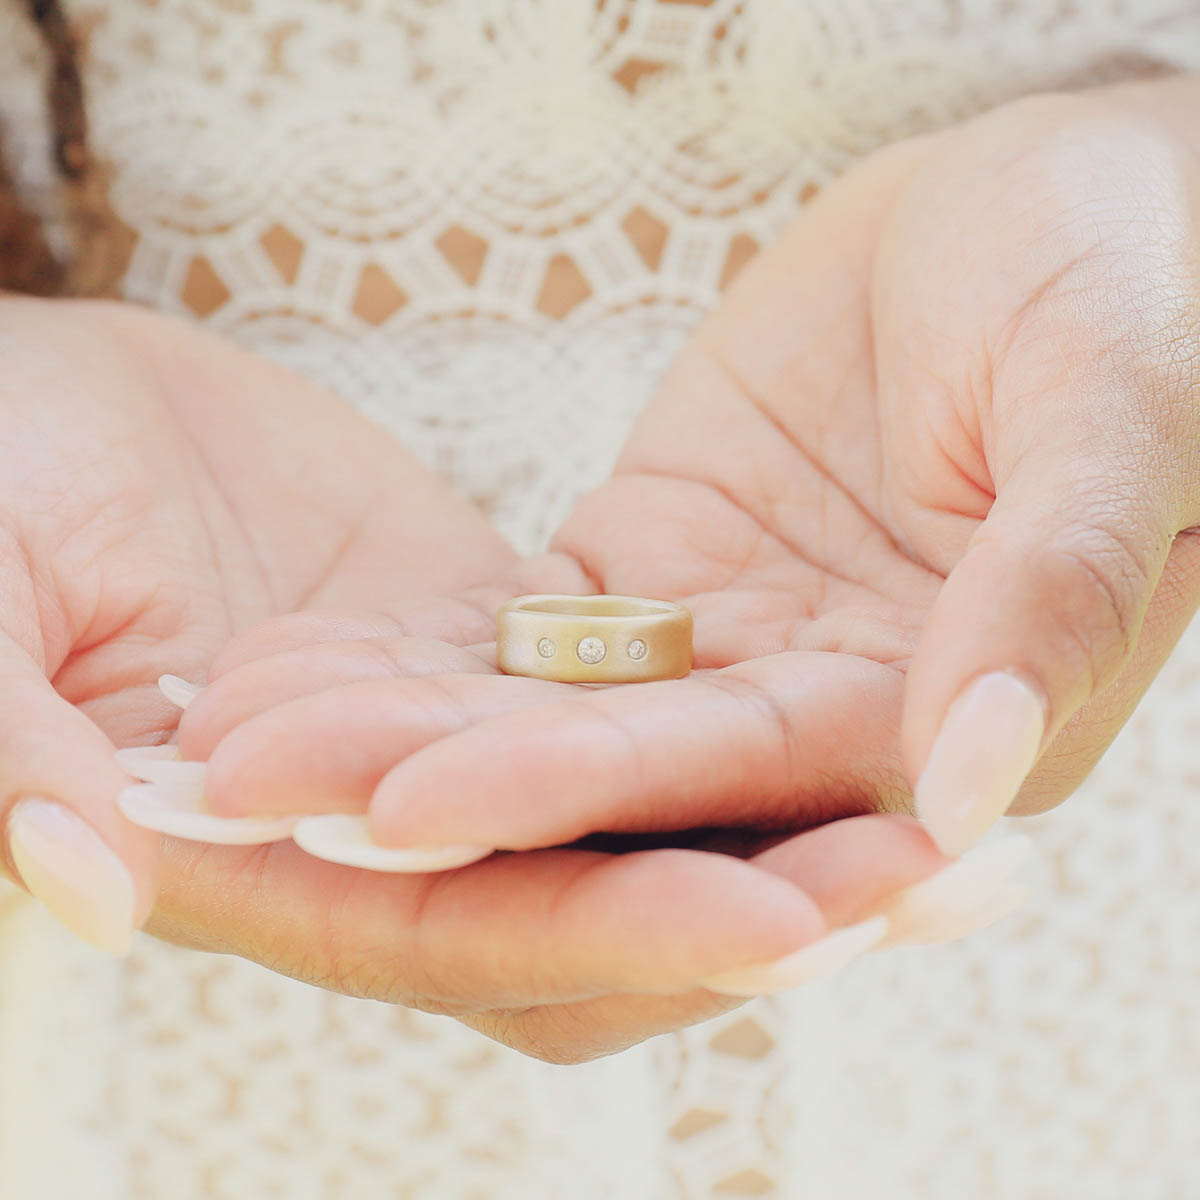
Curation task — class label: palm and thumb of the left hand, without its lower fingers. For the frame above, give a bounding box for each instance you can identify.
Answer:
[0,298,515,950]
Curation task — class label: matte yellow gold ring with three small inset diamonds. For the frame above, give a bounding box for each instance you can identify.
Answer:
[496,595,692,683]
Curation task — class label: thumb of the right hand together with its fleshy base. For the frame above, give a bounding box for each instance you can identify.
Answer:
[876,121,1200,853]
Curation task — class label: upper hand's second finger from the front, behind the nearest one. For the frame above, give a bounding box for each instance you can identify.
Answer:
[193,674,574,820]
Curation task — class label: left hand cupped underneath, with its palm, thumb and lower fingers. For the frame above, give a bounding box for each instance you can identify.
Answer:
[0,298,969,1061]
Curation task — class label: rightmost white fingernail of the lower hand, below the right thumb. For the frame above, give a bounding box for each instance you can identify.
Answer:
[870,835,1033,949]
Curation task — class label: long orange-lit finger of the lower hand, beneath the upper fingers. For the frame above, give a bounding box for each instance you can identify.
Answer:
[151,842,824,1012]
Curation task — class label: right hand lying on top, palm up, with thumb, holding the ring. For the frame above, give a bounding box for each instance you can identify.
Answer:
[182,89,1200,873]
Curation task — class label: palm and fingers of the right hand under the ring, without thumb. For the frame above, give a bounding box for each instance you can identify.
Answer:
[192,140,942,850]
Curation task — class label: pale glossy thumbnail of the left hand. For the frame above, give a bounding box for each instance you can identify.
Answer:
[8,796,136,954]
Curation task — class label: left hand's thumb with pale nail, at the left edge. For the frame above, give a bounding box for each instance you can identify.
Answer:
[0,635,158,954]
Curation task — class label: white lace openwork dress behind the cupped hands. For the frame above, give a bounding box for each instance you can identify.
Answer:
[0,0,1200,1200]
